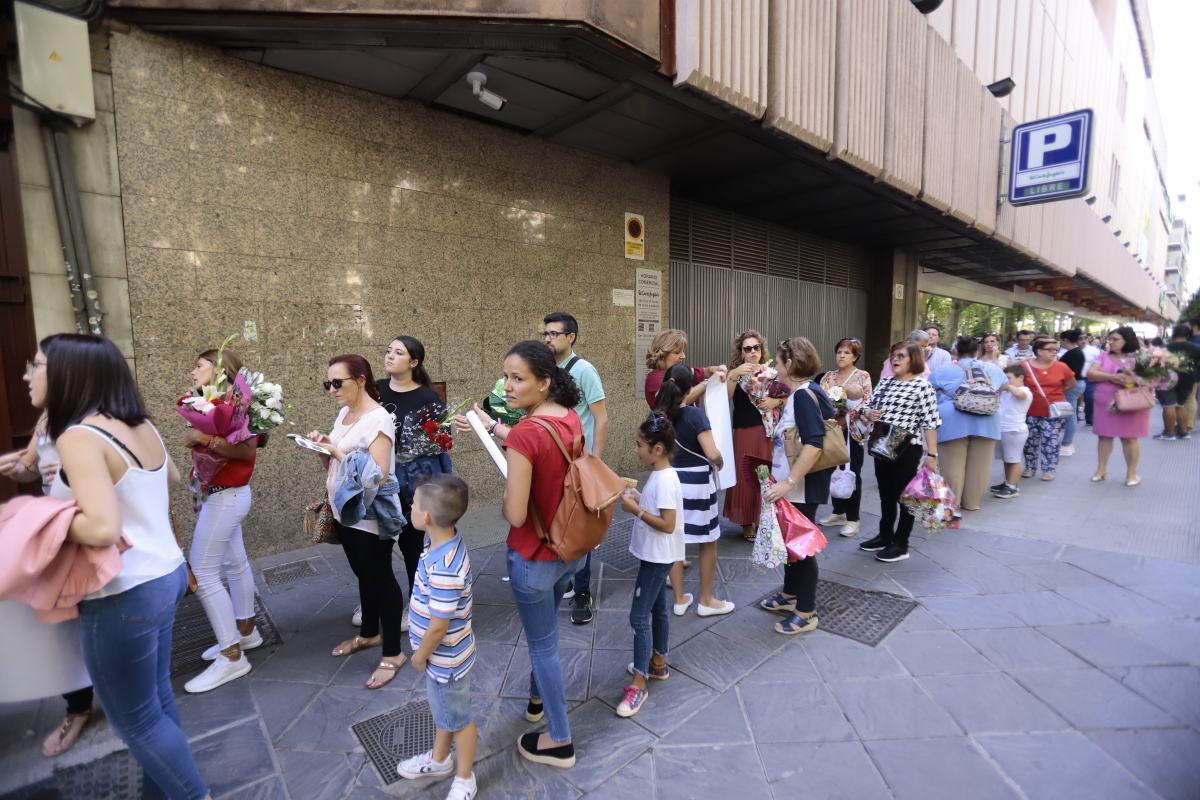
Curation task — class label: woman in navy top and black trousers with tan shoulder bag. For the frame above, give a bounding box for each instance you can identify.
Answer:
[760,336,834,636]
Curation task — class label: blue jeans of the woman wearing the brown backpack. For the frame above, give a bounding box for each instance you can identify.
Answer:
[508,548,583,741]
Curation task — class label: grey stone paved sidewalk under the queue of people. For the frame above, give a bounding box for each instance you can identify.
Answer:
[0,434,1200,800]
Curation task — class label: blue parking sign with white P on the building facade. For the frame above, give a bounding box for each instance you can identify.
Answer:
[1008,108,1092,205]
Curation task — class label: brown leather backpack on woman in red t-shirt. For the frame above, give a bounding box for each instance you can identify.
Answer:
[527,416,625,561]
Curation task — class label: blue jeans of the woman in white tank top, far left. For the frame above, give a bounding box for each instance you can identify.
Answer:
[79,565,209,800]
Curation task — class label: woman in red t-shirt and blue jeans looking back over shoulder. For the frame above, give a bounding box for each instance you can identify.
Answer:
[455,341,583,768]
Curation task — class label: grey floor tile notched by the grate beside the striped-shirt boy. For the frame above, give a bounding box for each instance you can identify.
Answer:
[275,686,413,753]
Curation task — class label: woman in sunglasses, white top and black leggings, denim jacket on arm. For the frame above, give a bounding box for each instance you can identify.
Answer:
[308,354,406,688]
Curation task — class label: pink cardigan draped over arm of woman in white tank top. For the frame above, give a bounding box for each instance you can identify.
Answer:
[0,497,128,622]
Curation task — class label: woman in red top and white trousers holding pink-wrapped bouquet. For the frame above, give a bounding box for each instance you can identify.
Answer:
[184,350,263,694]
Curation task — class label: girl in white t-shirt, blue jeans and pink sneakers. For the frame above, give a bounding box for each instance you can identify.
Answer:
[617,411,683,717]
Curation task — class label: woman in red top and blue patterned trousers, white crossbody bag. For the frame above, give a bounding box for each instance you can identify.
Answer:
[1021,336,1075,481]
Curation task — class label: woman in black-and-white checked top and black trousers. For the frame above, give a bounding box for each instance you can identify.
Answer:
[858,342,942,561]
